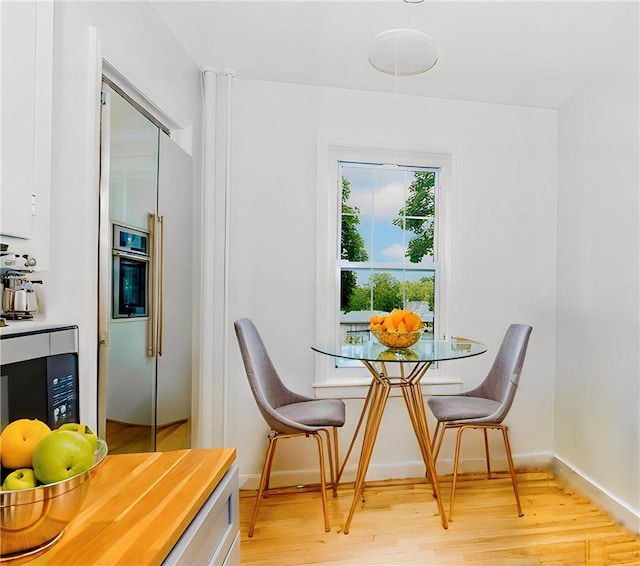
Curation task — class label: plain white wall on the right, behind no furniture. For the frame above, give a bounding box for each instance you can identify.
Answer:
[554,50,640,532]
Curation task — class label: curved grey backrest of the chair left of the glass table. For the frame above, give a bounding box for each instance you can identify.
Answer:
[233,318,315,434]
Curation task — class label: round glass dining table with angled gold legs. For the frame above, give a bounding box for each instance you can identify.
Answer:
[311,340,487,534]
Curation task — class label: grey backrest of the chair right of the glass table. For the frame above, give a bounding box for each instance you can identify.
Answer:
[465,324,533,423]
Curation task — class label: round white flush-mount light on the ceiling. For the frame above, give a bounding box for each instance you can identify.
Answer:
[369,29,438,77]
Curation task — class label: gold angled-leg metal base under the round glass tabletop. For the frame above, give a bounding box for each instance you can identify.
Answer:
[337,360,449,534]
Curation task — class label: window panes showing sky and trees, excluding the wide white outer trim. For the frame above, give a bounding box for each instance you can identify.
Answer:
[336,161,439,367]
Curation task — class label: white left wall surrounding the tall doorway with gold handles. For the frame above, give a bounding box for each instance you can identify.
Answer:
[43,2,201,426]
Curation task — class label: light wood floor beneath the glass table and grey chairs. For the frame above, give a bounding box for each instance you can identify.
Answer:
[240,471,640,566]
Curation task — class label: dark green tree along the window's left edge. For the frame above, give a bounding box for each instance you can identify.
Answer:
[340,177,369,312]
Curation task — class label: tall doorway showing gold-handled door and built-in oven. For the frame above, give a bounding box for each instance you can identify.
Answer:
[98,78,193,453]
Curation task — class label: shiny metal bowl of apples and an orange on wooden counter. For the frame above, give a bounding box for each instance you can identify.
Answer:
[0,419,107,561]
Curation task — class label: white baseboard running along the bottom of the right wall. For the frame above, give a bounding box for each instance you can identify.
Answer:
[551,457,640,534]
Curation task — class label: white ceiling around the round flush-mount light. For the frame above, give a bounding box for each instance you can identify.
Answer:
[152,0,639,108]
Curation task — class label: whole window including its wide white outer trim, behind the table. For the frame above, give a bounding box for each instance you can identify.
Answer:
[314,134,461,396]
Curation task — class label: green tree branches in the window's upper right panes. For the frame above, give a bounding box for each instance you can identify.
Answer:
[393,171,436,263]
